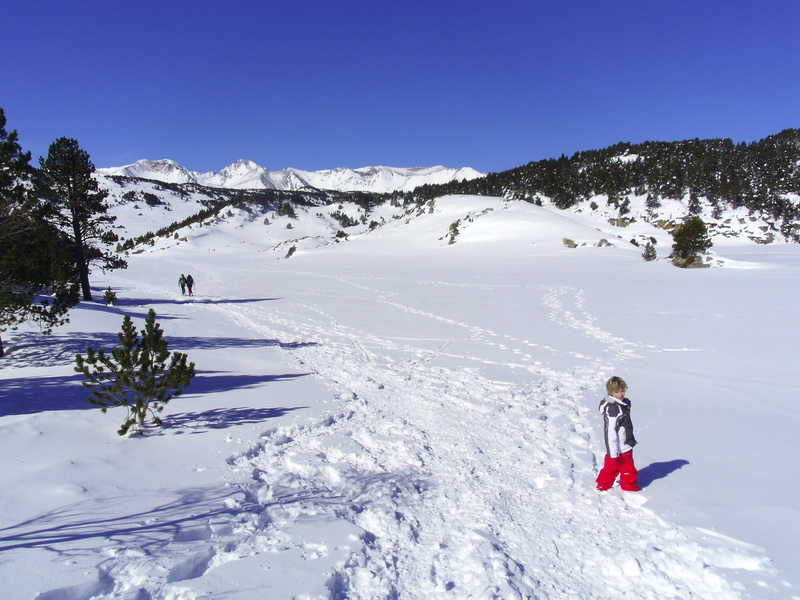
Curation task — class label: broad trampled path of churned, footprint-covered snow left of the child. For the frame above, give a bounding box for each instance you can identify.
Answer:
[92,278,770,600]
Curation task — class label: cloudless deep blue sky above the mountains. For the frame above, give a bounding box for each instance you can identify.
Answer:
[0,0,800,171]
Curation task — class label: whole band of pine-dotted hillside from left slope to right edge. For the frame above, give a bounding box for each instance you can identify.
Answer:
[100,129,800,251]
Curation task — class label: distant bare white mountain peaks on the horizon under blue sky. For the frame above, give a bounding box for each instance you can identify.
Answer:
[97,159,484,193]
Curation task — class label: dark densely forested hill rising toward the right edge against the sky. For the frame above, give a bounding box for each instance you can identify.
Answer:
[404,129,800,241]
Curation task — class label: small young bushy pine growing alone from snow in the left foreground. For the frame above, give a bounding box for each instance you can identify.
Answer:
[75,309,195,435]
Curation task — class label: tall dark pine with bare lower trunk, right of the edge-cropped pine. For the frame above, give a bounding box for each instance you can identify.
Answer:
[37,137,127,300]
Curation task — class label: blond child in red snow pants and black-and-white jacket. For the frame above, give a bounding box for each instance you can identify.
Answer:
[597,376,639,492]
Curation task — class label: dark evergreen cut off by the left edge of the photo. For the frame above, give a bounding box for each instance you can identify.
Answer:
[0,108,78,356]
